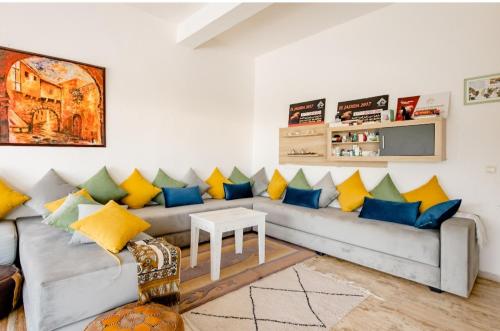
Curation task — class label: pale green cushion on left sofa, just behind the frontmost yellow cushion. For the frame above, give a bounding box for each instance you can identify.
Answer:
[43,194,98,232]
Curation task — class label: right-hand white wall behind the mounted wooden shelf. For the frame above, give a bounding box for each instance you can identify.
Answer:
[253,4,500,277]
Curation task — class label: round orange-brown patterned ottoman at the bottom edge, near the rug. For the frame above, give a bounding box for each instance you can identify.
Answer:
[85,303,184,331]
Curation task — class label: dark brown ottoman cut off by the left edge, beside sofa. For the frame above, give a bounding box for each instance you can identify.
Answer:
[0,265,23,319]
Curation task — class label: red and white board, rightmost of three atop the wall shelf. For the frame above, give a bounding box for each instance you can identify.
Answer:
[396,92,450,121]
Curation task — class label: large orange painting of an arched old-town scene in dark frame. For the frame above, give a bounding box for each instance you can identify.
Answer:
[0,47,106,147]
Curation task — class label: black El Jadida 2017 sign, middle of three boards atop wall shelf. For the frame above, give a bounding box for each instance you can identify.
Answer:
[337,95,389,123]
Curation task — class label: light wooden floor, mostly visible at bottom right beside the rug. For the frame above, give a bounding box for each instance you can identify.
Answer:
[0,237,500,331]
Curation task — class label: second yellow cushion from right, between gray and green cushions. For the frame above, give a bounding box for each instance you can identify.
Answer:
[337,170,372,211]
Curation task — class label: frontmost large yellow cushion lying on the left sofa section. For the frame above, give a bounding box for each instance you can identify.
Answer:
[70,200,150,253]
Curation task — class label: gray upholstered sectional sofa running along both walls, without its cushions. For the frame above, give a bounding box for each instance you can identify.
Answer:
[4,197,479,331]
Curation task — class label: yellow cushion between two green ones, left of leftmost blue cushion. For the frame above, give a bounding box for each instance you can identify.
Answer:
[120,169,161,209]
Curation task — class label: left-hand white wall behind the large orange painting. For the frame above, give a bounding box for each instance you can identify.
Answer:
[0,4,254,189]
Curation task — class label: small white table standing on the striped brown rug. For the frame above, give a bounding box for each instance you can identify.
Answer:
[189,207,267,280]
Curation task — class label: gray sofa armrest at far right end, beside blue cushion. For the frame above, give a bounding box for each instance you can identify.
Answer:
[441,217,479,297]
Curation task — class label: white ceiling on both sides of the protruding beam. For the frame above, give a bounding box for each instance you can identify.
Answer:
[133,3,388,57]
